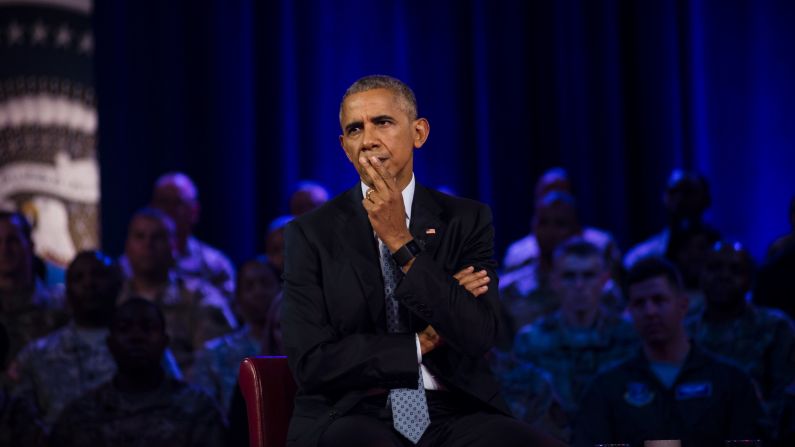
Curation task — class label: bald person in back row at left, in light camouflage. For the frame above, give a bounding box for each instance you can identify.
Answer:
[121,172,235,300]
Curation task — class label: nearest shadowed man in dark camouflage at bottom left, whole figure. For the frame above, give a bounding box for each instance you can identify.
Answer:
[50,298,224,447]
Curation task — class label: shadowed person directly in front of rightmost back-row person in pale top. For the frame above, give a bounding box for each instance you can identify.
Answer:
[665,220,720,316]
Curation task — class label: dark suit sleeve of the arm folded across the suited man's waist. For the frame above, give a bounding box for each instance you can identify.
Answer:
[282,221,419,394]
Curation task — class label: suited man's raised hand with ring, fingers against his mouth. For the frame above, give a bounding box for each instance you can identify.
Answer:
[359,156,412,253]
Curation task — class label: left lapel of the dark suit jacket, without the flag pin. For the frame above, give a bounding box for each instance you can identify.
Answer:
[335,184,386,329]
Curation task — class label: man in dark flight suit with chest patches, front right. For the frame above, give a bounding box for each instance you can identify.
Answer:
[574,258,761,447]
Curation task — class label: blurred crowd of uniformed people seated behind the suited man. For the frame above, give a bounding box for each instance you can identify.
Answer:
[0,168,795,447]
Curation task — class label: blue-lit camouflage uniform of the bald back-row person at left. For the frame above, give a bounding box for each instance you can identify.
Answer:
[119,237,235,301]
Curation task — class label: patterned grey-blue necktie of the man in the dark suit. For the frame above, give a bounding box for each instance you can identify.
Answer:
[378,243,431,444]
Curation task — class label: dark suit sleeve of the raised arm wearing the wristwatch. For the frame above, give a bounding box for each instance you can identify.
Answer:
[395,205,500,357]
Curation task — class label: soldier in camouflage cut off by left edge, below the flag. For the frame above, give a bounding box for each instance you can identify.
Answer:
[0,211,67,372]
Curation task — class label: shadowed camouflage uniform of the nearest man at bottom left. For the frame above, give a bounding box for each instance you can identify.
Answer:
[51,379,224,447]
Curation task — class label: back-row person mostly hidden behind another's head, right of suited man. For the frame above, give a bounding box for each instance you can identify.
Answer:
[502,168,621,272]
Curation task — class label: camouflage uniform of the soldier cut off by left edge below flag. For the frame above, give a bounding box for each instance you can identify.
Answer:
[0,280,68,371]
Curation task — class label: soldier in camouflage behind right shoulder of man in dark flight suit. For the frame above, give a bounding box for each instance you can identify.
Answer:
[687,242,795,430]
